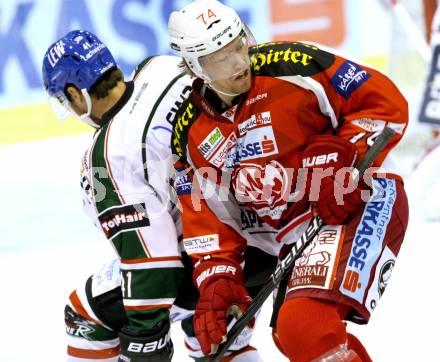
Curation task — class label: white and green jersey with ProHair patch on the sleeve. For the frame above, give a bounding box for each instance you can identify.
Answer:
[81,56,191,330]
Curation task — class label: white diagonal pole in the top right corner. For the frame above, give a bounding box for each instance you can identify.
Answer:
[381,0,432,63]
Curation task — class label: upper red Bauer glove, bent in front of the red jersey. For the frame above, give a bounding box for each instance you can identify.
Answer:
[302,135,363,225]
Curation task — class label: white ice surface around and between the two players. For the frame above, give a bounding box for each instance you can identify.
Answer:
[0,134,440,362]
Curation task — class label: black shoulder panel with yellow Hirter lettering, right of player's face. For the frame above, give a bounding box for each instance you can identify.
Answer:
[250,42,335,77]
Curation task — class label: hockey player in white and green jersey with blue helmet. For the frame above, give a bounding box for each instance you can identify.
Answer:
[43,31,276,362]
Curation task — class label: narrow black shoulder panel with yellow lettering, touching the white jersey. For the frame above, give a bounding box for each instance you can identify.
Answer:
[171,94,200,159]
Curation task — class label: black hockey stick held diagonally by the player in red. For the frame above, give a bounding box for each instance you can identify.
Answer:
[210,127,395,362]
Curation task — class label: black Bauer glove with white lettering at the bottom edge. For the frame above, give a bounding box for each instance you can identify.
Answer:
[118,320,174,362]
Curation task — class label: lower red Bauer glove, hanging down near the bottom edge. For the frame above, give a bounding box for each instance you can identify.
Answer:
[194,260,251,356]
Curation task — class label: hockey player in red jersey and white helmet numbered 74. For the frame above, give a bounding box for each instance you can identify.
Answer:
[168,0,408,362]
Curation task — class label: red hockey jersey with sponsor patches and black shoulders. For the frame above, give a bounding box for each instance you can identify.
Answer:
[172,42,408,262]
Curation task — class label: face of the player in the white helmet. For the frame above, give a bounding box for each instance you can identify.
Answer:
[201,36,252,95]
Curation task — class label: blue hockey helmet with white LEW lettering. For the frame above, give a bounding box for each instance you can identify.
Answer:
[43,30,117,123]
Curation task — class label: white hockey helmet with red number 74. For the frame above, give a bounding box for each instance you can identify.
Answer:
[168,0,255,82]
